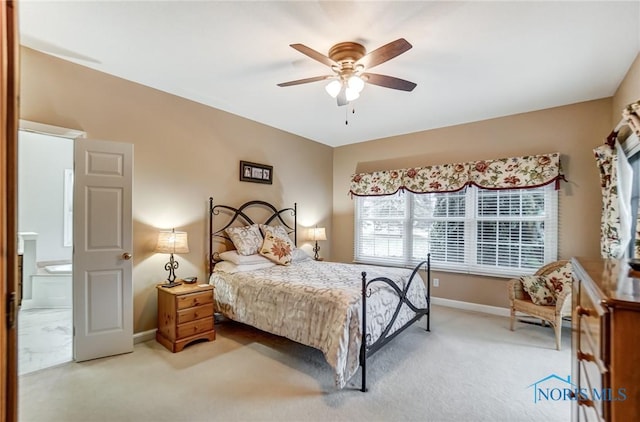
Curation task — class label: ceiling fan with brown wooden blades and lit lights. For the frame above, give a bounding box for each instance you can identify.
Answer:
[278,38,416,106]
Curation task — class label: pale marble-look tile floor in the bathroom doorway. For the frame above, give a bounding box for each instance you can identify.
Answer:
[18,308,73,375]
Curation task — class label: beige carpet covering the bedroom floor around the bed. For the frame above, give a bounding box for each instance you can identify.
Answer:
[19,307,570,422]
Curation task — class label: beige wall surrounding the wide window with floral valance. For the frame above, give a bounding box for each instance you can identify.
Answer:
[332,98,611,307]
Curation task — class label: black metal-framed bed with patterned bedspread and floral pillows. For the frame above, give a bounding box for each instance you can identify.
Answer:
[209,198,430,392]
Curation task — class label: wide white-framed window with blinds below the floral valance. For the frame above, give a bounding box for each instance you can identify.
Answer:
[355,184,558,276]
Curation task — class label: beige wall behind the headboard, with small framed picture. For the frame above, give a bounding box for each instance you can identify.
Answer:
[20,48,332,332]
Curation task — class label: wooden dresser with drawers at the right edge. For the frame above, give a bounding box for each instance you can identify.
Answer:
[571,258,640,422]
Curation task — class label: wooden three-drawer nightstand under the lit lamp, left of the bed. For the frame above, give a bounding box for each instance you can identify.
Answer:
[156,284,216,353]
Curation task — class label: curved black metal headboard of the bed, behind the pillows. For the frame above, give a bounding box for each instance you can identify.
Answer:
[209,197,298,275]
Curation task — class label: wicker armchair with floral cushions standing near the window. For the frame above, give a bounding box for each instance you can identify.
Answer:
[507,261,571,350]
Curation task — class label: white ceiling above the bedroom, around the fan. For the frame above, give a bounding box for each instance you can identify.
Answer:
[19,0,640,146]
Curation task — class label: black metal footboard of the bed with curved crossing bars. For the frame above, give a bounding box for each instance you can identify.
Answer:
[360,254,431,392]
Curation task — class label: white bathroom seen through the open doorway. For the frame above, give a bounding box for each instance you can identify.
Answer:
[18,130,73,375]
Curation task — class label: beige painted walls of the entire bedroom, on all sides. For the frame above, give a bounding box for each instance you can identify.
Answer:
[20,44,640,326]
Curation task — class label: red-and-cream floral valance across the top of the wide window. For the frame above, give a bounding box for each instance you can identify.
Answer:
[350,152,564,196]
